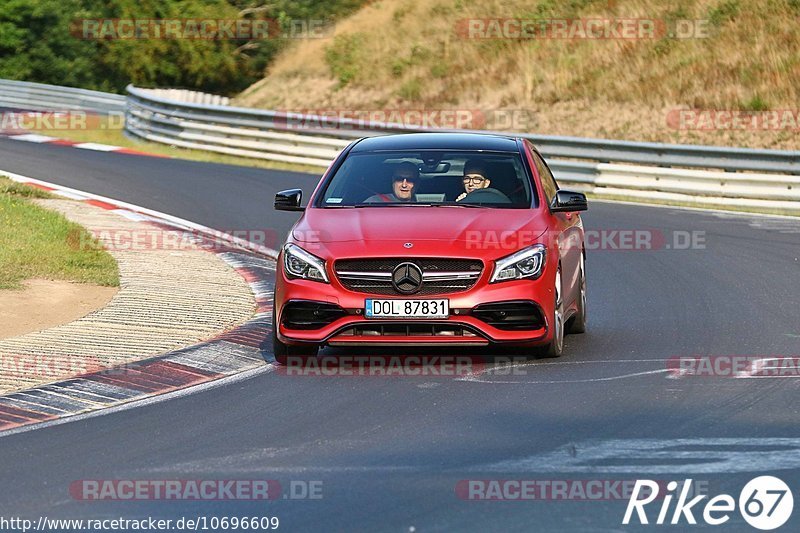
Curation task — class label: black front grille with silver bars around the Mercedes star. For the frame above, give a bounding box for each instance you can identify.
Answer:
[334,257,483,296]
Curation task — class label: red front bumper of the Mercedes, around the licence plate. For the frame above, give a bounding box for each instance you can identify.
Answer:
[274,263,554,346]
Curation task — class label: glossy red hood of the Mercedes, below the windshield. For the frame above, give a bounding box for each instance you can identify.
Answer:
[292,207,547,243]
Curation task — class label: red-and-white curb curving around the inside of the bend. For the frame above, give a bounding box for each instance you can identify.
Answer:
[0,171,277,435]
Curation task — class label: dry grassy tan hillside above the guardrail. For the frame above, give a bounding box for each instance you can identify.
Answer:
[237,0,800,149]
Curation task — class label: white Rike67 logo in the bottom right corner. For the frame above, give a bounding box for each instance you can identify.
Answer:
[622,476,794,531]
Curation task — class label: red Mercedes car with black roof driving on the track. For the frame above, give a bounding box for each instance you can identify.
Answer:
[273,133,587,363]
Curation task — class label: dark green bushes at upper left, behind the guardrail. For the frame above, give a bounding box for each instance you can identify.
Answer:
[0,0,364,95]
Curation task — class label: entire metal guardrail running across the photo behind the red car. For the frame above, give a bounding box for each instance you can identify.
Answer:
[0,80,800,214]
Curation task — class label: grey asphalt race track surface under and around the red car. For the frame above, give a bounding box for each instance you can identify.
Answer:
[0,135,800,531]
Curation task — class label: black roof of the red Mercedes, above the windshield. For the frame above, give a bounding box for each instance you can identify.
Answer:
[351,133,519,152]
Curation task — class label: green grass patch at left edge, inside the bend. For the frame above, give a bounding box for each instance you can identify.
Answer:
[0,177,119,289]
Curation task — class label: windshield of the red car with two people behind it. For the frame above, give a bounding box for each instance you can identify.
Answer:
[316,151,535,209]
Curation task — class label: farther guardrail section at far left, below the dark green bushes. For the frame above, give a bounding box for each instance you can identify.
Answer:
[0,80,125,114]
